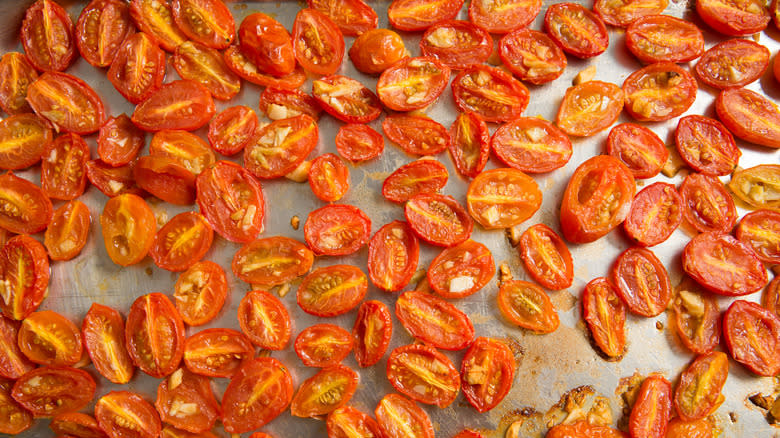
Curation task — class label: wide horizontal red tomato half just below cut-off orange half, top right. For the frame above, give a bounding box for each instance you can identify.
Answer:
[626,15,704,63]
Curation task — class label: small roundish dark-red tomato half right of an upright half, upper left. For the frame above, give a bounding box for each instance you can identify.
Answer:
[97,114,146,167]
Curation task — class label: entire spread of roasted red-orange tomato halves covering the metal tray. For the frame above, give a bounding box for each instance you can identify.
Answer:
[0,0,780,438]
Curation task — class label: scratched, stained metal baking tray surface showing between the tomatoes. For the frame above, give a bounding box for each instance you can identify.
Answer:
[0,0,780,438]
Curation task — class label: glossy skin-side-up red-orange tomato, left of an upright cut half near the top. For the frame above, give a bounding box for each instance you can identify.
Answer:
[238,12,295,77]
